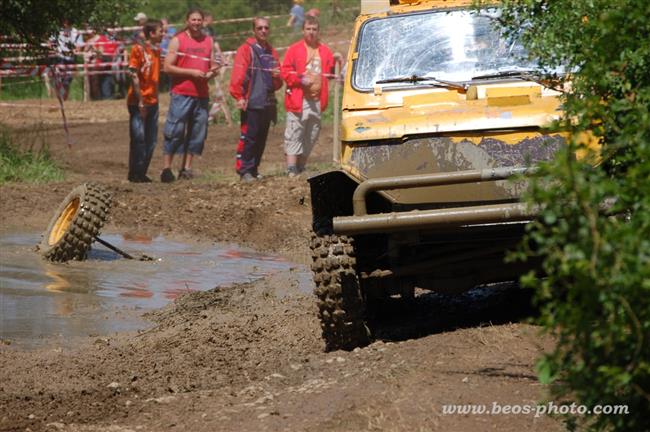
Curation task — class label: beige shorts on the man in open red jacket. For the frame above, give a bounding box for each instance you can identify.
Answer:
[284,99,320,158]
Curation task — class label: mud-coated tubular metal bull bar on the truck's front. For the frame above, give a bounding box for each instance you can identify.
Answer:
[333,168,535,235]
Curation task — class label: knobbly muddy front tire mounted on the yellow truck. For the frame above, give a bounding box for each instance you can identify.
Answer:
[311,234,370,351]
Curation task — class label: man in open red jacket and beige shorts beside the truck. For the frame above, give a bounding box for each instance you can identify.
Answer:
[281,15,334,177]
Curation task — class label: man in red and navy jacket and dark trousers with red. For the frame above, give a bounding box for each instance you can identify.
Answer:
[230,18,282,182]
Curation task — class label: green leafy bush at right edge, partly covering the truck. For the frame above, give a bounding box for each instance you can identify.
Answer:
[486,0,650,431]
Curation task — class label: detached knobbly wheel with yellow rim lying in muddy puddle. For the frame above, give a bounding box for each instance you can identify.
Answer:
[38,183,111,262]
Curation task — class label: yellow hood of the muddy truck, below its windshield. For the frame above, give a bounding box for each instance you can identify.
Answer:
[341,82,560,141]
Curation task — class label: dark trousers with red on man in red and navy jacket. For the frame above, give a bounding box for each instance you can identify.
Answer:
[235,107,275,176]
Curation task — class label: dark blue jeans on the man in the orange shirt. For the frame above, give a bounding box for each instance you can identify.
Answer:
[129,104,158,180]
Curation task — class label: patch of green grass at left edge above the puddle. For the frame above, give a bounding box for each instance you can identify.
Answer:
[0,125,63,184]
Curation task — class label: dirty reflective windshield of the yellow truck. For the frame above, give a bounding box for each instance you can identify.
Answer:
[352,9,556,90]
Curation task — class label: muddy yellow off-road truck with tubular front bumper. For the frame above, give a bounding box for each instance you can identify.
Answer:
[309,0,564,350]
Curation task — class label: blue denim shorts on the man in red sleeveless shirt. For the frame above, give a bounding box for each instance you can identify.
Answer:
[163,93,208,155]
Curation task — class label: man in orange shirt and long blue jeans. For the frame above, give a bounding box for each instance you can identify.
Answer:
[127,20,163,183]
